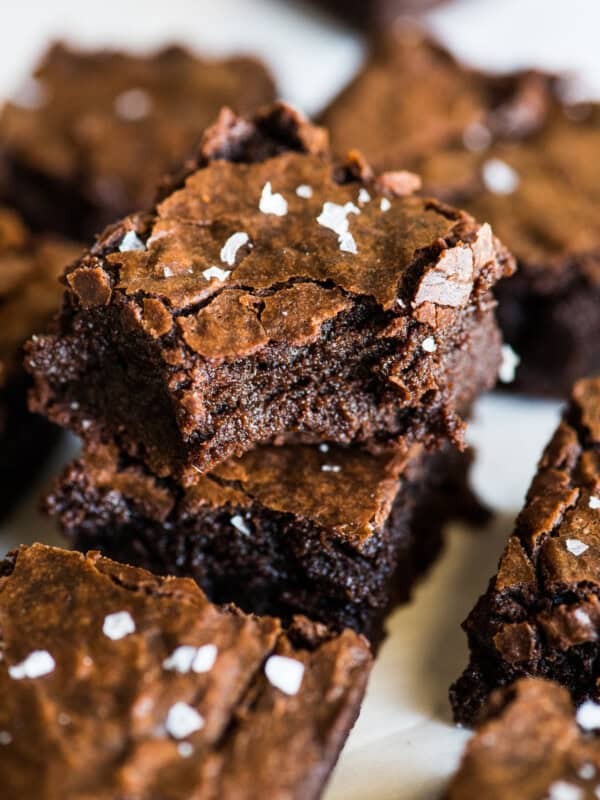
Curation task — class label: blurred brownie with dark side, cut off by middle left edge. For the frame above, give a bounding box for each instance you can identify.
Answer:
[0,206,81,517]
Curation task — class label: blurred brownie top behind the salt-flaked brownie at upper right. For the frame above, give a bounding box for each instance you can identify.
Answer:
[322,25,553,169]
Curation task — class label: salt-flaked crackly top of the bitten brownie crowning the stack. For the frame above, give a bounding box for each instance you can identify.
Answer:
[59,104,512,359]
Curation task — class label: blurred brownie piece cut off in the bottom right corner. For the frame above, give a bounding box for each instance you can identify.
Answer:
[445,678,600,800]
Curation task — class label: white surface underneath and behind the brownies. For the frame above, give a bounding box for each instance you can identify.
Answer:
[0,0,600,800]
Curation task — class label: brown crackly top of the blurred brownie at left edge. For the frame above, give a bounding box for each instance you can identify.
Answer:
[0,206,81,386]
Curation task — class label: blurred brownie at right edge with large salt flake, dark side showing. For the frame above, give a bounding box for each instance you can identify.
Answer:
[412,103,600,396]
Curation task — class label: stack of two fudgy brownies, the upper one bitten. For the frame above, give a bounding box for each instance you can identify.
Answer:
[27,104,513,642]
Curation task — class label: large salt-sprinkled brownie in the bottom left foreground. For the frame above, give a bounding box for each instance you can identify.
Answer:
[0,545,371,800]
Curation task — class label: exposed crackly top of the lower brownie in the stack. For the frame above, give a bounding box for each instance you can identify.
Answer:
[66,444,421,547]
